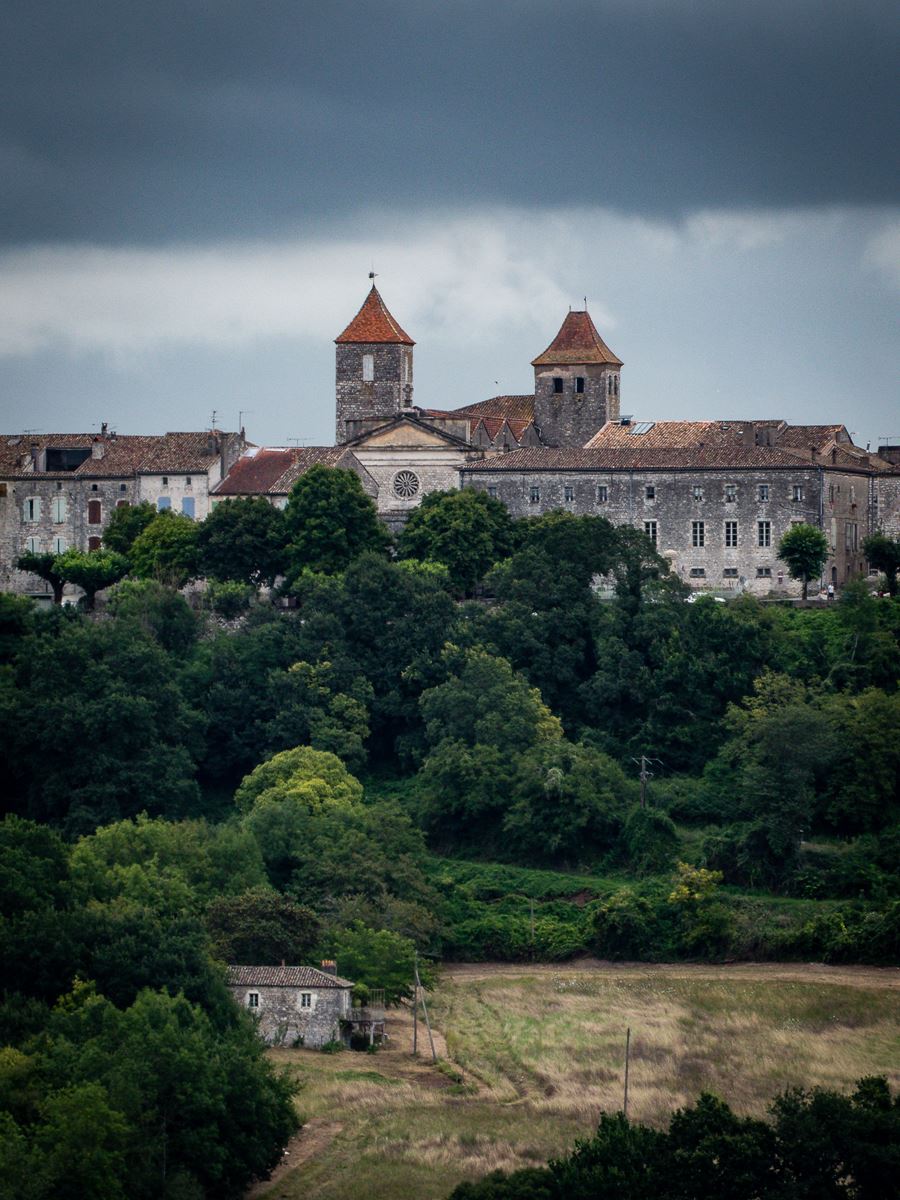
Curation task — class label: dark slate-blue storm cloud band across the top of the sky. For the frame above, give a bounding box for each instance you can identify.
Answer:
[0,0,898,244]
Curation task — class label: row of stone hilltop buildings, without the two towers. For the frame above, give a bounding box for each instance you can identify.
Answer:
[0,412,900,596]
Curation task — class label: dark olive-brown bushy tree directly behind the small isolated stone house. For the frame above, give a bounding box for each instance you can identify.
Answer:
[206,888,319,966]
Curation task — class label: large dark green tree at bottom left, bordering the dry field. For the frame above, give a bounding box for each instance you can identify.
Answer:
[47,986,298,1200]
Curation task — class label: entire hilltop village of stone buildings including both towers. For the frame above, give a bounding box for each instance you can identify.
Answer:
[0,284,900,596]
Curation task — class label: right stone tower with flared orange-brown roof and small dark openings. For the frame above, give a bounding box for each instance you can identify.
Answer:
[532,308,622,446]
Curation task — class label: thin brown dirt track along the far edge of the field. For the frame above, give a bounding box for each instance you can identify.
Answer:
[440,959,900,989]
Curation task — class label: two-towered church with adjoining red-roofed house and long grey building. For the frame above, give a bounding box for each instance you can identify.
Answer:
[211,284,900,594]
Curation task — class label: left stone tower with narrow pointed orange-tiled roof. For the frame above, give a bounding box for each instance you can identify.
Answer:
[335,276,415,445]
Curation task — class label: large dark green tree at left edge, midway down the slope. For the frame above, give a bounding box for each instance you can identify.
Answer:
[2,619,203,833]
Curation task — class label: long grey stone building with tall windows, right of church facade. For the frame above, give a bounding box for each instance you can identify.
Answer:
[461,418,886,594]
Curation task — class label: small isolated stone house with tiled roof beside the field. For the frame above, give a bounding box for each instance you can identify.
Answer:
[228,962,353,1049]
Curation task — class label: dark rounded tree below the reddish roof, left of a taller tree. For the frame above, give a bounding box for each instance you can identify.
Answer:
[198,496,287,587]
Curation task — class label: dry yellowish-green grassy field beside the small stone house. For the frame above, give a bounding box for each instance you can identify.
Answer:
[252,964,900,1200]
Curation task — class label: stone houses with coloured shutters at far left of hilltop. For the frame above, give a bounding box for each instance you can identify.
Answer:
[0,426,246,598]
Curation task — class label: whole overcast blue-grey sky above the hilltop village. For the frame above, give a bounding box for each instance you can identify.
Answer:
[0,0,900,444]
